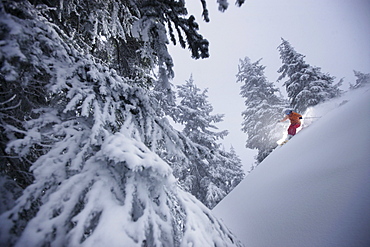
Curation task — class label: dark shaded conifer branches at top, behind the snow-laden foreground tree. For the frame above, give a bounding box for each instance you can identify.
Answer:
[21,0,209,100]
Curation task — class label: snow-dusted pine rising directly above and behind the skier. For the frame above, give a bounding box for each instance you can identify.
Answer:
[278,39,342,113]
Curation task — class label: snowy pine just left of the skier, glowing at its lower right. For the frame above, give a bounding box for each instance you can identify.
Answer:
[236,57,287,163]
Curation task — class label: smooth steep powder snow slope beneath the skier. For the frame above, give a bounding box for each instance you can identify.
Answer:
[213,88,370,247]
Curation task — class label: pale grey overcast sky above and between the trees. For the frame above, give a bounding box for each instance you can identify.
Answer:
[170,0,370,167]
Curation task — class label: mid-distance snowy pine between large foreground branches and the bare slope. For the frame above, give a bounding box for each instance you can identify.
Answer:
[173,77,244,208]
